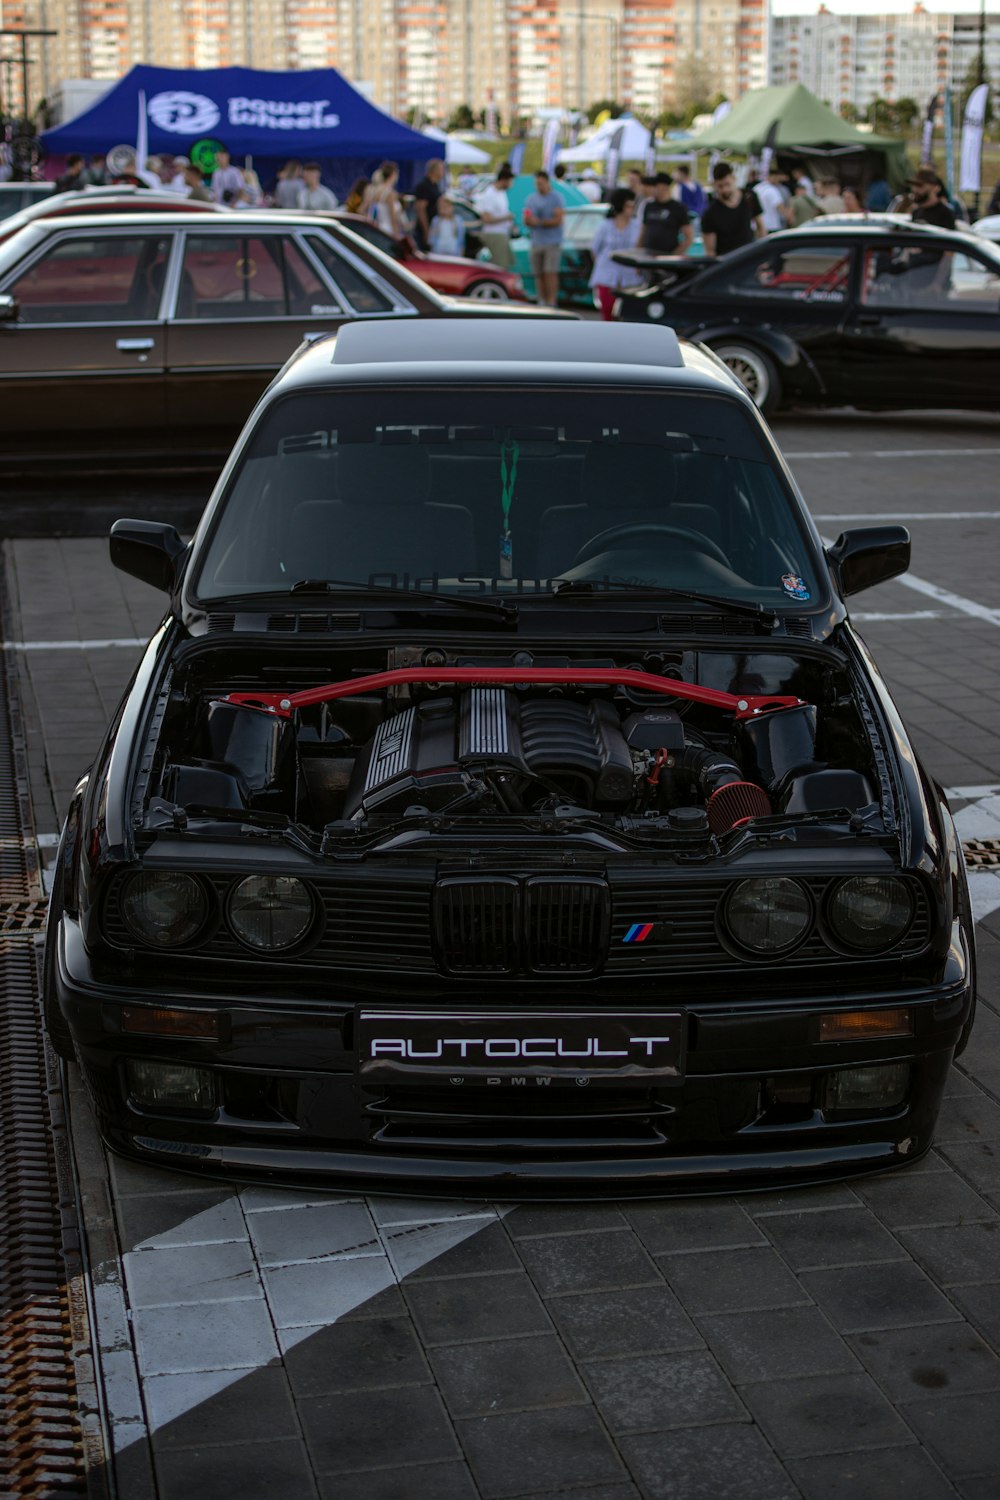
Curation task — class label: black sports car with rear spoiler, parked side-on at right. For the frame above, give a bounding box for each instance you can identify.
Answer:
[616,215,1000,411]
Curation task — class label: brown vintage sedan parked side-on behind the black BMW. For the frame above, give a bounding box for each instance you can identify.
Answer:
[0,210,565,471]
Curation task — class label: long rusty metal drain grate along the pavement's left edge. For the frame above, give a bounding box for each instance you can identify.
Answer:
[0,618,93,1500]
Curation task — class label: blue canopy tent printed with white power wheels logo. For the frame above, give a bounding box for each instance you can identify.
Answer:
[42,66,444,197]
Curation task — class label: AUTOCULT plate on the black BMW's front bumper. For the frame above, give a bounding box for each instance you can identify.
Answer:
[357,1008,684,1088]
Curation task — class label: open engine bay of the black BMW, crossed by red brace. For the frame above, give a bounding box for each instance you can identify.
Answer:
[145,648,879,839]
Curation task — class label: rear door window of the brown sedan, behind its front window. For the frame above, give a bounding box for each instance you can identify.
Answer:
[177,234,320,318]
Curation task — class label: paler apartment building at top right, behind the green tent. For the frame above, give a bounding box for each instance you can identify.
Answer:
[769,3,1000,110]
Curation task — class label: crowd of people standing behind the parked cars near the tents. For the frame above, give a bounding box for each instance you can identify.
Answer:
[43,149,1000,318]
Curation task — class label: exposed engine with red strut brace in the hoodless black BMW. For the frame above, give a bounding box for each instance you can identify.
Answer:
[150,651,876,837]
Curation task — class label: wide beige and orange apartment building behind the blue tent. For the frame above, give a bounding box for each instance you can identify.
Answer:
[0,0,769,120]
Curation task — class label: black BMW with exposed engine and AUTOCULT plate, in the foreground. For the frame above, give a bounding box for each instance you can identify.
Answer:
[45,323,975,1196]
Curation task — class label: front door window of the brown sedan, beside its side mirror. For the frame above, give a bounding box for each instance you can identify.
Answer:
[6,234,169,323]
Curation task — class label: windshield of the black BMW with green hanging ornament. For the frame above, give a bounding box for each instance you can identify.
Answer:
[195,387,819,608]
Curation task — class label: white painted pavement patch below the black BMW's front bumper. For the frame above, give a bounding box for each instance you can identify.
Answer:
[112,1188,511,1452]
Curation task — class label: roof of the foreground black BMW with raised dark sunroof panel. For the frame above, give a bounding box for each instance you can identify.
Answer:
[271,318,746,410]
